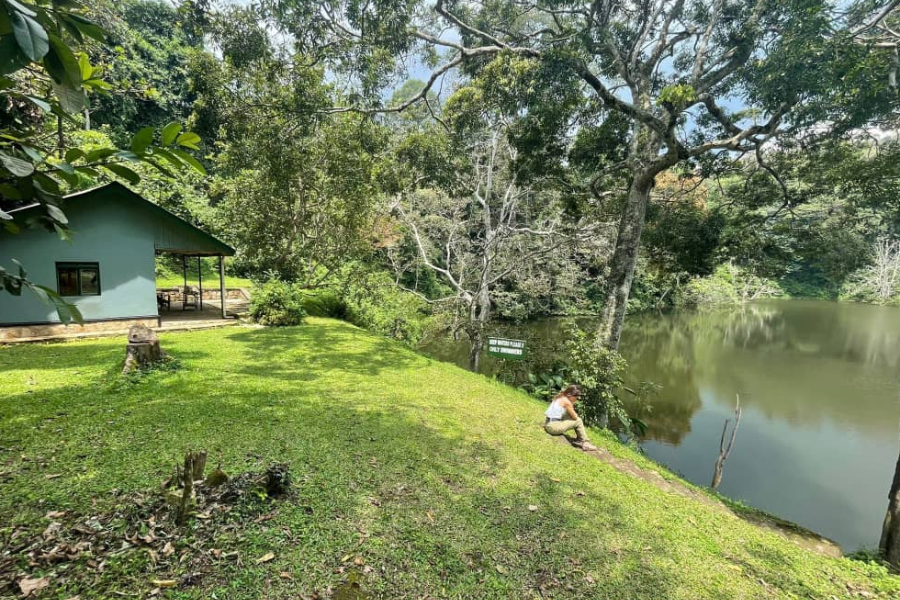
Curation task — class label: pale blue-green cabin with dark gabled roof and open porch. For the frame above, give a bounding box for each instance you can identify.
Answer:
[0,183,234,339]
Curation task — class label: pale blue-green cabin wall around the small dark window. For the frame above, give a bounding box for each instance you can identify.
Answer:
[0,196,158,325]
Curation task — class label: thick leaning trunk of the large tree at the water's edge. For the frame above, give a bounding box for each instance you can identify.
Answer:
[597,171,654,350]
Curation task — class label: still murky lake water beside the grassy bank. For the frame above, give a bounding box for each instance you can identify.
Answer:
[425,300,900,551]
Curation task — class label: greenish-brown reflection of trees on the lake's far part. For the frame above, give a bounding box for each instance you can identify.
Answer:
[622,301,900,443]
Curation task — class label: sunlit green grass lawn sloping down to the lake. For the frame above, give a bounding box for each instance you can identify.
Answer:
[0,319,900,600]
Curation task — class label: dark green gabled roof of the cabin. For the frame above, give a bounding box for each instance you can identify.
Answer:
[7,182,234,256]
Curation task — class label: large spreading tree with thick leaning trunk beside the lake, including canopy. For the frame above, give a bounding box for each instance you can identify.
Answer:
[266,0,898,347]
